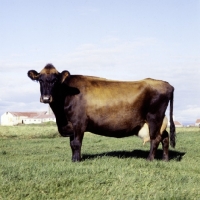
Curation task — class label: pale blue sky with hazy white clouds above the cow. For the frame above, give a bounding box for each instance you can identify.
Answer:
[0,0,200,123]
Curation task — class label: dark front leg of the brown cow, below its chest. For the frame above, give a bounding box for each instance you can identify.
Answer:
[70,134,83,162]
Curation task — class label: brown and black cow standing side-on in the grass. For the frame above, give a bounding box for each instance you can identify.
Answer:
[28,64,176,162]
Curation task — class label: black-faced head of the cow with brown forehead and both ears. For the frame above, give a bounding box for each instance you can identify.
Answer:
[28,64,70,103]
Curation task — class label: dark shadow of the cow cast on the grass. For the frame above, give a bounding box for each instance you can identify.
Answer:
[82,149,185,161]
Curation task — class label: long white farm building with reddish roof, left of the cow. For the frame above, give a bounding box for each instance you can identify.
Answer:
[1,111,56,126]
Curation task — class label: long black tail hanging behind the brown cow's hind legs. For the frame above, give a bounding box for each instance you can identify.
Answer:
[169,88,176,148]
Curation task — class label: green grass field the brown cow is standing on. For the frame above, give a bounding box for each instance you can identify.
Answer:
[0,124,200,200]
